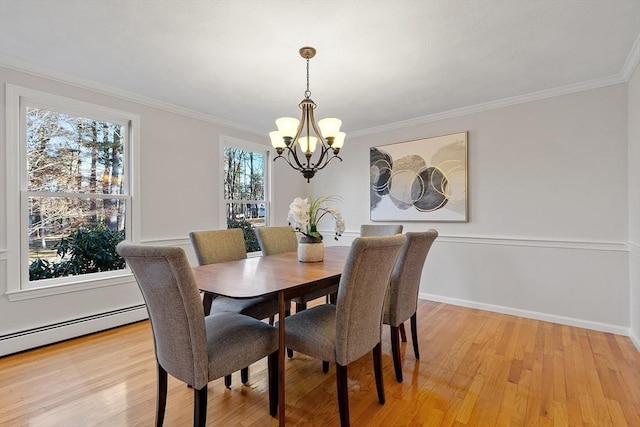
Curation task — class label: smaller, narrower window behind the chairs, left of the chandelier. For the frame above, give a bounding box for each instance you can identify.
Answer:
[222,138,269,252]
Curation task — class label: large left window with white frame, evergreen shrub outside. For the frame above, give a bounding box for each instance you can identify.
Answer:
[7,87,135,289]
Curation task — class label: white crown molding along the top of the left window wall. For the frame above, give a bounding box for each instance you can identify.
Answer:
[0,55,264,136]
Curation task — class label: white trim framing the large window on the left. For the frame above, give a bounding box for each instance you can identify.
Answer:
[5,83,141,301]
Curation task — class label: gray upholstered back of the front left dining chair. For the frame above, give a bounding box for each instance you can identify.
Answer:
[116,242,209,389]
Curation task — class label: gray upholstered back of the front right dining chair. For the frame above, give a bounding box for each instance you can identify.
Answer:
[336,234,405,366]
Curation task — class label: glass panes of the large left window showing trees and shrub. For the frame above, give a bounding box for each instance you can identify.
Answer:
[22,105,129,282]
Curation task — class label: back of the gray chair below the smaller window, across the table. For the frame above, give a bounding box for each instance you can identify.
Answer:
[189,228,247,265]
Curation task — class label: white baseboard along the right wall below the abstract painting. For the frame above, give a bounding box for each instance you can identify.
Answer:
[418,293,640,340]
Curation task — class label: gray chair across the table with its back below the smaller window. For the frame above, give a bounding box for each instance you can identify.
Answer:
[189,228,278,388]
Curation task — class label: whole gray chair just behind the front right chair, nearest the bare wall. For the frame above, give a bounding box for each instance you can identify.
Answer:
[383,229,438,382]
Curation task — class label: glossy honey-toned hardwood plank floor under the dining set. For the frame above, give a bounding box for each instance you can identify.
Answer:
[0,301,640,427]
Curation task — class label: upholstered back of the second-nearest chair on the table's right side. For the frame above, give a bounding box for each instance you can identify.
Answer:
[384,229,438,326]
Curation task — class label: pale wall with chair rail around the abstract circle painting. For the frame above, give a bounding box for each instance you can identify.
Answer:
[314,84,630,335]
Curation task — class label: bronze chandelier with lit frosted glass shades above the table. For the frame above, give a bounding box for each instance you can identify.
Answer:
[269,46,345,182]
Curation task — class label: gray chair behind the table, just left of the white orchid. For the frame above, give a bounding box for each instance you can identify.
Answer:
[255,226,338,312]
